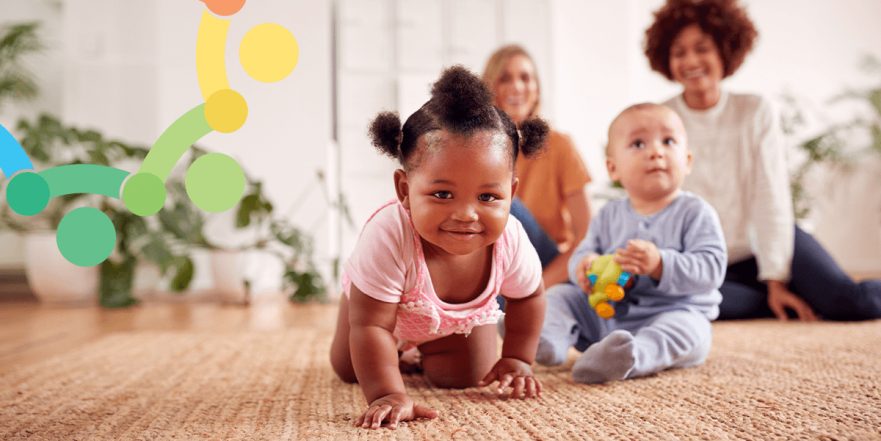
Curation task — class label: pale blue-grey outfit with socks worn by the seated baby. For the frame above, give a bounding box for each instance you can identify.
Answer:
[536,192,727,383]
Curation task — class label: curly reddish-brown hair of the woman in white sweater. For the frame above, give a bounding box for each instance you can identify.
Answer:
[644,0,758,80]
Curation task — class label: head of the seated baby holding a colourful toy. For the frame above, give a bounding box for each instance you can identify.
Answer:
[606,105,691,201]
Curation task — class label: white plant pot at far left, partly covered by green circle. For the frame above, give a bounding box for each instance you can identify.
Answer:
[24,231,99,306]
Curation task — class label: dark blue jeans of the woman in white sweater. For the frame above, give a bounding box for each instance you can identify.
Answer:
[719,227,881,320]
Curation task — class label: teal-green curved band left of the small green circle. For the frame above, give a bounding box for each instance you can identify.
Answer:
[39,164,128,199]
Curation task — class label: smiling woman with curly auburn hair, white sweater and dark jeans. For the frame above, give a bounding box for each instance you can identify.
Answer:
[645,0,881,321]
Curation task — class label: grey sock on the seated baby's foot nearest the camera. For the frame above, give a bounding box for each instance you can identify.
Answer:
[572,329,636,384]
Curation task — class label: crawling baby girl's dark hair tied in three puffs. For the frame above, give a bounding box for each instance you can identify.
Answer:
[370,66,548,170]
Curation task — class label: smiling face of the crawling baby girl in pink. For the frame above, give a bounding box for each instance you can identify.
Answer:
[395,131,517,255]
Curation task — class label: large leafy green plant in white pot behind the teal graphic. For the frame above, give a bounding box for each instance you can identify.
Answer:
[0,114,201,307]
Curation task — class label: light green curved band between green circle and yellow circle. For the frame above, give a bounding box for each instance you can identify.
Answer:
[138,103,213,182]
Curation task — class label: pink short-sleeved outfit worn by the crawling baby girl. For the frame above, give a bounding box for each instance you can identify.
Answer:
[342,201,541,349]
